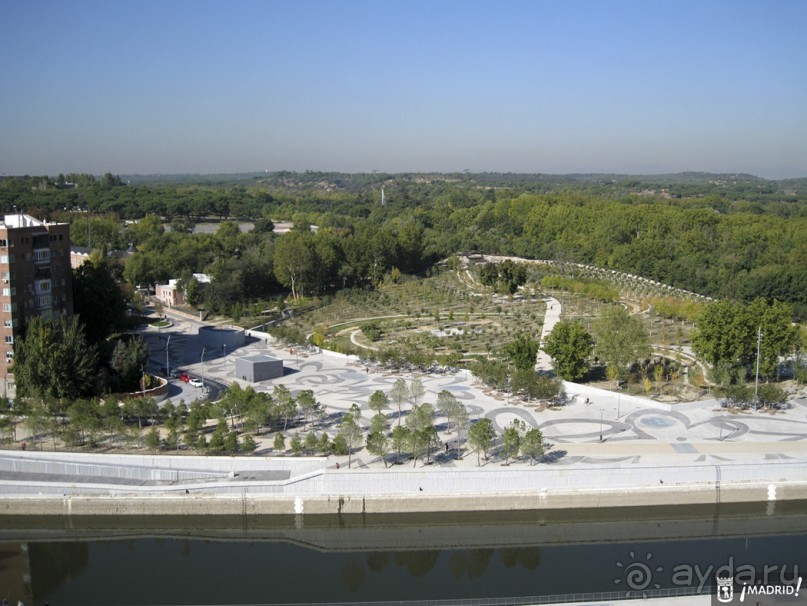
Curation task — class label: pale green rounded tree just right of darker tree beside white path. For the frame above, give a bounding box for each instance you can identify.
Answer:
[594,305,651,373]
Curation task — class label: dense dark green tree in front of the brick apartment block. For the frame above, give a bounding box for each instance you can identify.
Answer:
[12,316,98,400]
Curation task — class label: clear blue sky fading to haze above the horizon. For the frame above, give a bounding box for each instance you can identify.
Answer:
[0,0,807,178]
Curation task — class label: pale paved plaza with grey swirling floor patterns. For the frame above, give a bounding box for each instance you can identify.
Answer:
[144,300,807,476]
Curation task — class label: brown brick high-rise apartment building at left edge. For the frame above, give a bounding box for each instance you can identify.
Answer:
[0,215,73,381]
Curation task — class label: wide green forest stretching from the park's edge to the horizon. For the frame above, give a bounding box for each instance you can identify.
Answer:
[0,171,807,320]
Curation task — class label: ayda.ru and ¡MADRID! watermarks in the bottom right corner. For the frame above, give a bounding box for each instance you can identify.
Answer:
[614,551,807,603]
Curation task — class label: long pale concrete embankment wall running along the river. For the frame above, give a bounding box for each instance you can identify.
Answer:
[0,452,807,516]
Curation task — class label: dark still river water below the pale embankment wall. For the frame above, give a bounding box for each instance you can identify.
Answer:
[9,505,807,606]
